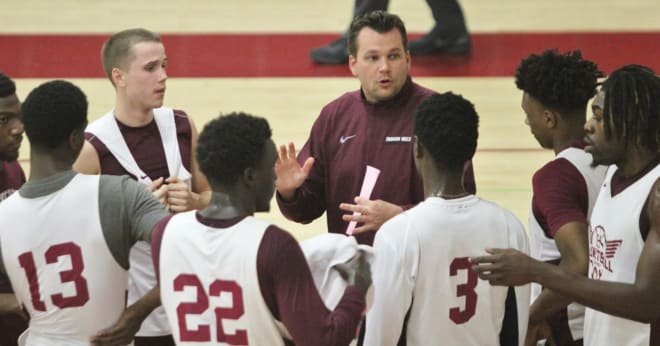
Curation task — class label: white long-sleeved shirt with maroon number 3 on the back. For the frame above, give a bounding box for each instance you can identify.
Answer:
[365,195,530,346]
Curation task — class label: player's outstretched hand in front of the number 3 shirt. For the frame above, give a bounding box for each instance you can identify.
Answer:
[470,249,537,286]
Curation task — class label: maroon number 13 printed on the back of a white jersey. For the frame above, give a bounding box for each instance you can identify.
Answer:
[18,242,89,311]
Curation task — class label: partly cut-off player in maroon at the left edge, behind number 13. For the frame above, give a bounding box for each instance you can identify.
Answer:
[0,72,27,346]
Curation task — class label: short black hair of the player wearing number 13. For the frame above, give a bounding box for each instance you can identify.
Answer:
[21,80,87,149]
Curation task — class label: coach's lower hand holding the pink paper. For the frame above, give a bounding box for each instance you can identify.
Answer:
[339,197,403,234]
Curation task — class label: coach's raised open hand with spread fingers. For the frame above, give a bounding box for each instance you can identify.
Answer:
[275,143,314,201]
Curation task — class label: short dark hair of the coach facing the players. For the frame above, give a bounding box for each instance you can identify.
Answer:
[348,11,408,56]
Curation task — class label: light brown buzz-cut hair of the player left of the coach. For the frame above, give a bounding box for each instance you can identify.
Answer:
[101,28,161,84]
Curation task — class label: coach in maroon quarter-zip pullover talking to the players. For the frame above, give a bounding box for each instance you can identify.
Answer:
[276,11,476,244]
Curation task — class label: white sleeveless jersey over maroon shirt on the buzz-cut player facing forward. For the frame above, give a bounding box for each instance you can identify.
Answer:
[86,107,192,337]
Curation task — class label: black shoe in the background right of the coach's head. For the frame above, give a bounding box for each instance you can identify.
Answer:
[408,31,472,55]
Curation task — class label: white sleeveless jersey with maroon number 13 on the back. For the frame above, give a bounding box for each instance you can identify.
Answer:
[0,174,127,346]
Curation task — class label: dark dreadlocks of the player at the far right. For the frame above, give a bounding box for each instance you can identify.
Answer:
[602,65,660,152]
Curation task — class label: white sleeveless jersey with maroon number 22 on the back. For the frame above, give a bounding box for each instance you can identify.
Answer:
[159,211,283,346]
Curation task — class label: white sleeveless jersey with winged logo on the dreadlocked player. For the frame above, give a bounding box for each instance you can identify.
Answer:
[584,166,660,346]
